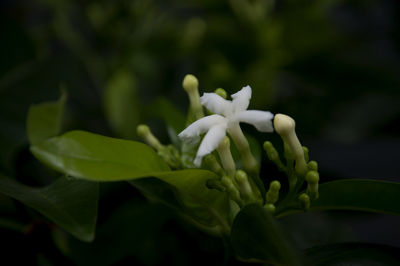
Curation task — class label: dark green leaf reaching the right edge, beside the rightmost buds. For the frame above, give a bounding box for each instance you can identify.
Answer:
[311,179,400,215]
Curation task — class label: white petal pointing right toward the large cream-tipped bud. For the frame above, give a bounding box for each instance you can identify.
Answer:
[235,110,274,132]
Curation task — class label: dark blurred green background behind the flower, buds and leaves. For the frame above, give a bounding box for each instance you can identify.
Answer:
[0,0,400,265]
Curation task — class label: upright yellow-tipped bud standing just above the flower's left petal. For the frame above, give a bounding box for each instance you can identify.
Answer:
[182,74,204,120]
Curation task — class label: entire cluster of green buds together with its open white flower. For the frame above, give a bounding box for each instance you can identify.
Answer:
[137,75,319,212]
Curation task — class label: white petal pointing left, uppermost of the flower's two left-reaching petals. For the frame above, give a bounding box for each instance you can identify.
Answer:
[178,115,226,140]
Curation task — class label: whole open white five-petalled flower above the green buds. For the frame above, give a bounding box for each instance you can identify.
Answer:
[178,86,274,167]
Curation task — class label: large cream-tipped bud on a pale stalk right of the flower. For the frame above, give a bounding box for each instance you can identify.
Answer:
[274,114,307,175]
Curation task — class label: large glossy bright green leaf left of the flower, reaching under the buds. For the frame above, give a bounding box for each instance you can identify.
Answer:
[31,131,229,229]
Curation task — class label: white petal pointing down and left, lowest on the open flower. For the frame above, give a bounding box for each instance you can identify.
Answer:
[194,124,227,167]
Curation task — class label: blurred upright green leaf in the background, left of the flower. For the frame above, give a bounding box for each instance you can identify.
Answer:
[103,69,140,138]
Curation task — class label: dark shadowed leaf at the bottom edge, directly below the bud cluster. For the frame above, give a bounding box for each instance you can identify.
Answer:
[231,204,300,265]
